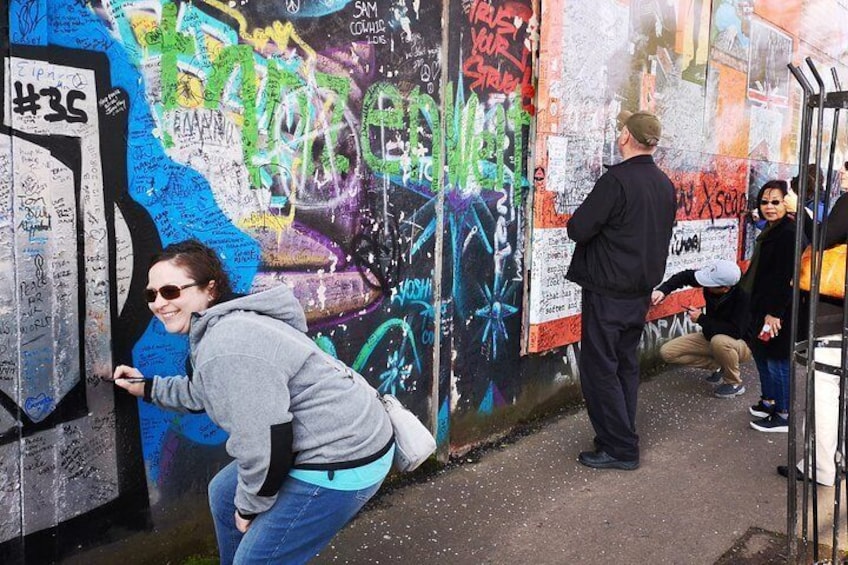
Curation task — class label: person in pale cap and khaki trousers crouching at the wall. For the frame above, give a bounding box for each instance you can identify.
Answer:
[651,260,751,398]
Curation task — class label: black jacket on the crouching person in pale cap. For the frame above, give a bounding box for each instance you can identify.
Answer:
[657,269,751,339]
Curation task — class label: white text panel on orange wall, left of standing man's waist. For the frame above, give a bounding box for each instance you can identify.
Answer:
[530,228,580,324]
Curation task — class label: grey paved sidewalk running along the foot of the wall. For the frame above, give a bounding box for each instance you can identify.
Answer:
[315,363,800,565]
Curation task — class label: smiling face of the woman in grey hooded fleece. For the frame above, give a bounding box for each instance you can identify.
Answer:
[147,261,215,334]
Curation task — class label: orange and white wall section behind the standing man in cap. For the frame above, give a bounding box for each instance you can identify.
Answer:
[526,0,848,351]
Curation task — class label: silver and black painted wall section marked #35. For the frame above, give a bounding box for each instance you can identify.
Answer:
[0,32,152,553]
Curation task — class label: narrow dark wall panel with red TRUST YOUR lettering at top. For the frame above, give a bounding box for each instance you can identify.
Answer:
[442,0,538,444]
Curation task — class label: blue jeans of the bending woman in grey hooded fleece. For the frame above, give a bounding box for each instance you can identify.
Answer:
[209,461,382,565]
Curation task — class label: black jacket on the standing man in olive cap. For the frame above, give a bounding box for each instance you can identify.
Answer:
[566,155,677,298]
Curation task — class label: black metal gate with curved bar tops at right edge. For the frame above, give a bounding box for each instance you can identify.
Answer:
[787,57,848,563]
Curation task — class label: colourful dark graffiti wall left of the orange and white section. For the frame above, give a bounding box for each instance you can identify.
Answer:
[0,0,538,561]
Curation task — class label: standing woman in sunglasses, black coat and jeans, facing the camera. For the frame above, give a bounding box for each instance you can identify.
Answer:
[739,180,795,433]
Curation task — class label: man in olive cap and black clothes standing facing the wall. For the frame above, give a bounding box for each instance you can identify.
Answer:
[566,108,676,470]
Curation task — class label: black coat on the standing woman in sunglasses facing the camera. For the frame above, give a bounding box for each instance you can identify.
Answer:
[745,216,795,358]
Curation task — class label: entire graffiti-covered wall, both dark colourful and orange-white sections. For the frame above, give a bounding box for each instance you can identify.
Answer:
[0,0,848,562]
